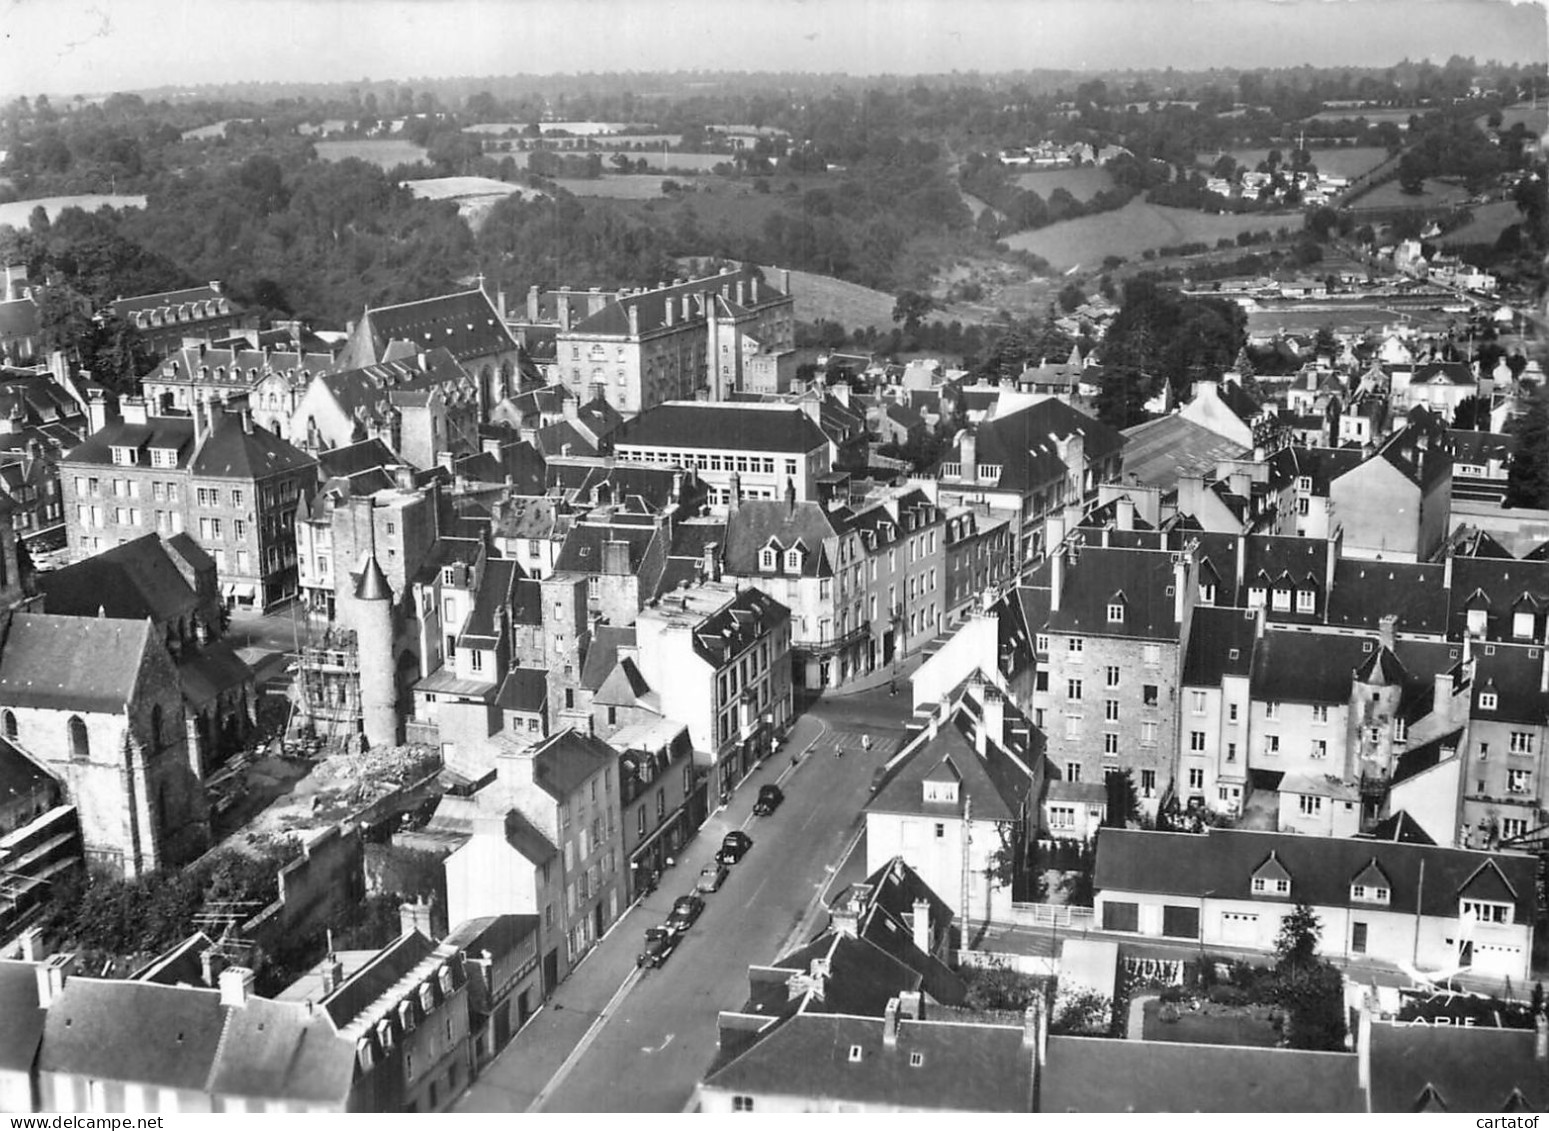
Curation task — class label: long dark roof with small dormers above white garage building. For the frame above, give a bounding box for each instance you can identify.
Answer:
[1094,829,1538,923]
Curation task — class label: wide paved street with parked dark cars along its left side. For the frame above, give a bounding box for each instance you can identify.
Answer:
[457,691,908,1112]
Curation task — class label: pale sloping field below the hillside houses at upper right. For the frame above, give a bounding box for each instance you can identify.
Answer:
[1004,198,1301,271]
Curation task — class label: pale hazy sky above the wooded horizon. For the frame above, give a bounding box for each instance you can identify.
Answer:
[0,0,1549,99]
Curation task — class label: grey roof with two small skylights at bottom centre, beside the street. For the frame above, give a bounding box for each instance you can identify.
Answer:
[705,1013,1033,1112]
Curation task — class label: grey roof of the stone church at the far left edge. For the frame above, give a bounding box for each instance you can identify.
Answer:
[0,612,160,714]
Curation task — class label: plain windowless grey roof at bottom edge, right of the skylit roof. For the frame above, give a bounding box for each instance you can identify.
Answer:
[1039,1028,1365,1112]
